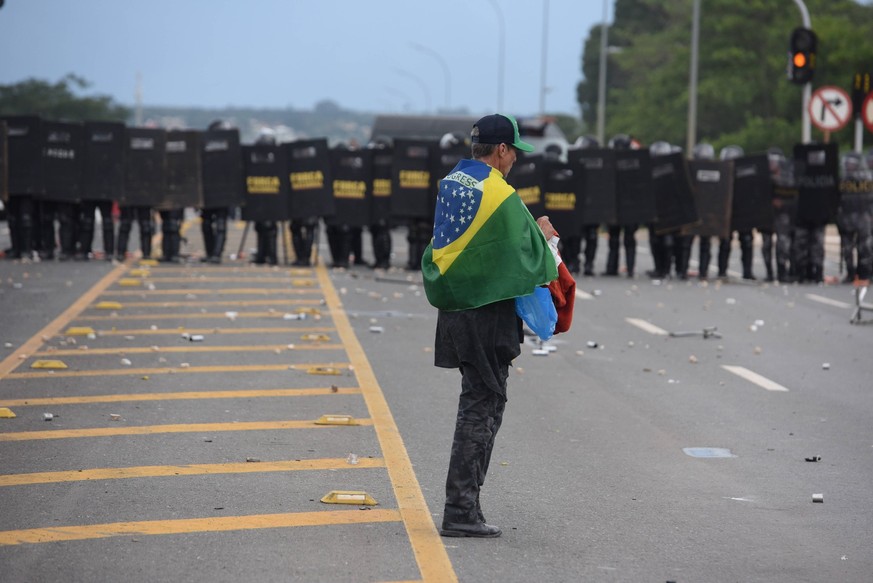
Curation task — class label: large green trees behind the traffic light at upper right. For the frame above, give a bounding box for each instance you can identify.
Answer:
[577,0,873,152]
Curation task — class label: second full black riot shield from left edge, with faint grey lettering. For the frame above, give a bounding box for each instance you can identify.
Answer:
[42,121,85,202]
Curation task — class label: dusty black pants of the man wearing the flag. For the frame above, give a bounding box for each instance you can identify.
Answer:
[443,364,509,524]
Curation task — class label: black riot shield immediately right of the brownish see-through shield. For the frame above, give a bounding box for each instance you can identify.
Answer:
[731,154,773,231]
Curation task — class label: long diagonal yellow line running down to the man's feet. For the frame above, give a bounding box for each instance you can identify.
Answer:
[317,265,457,581]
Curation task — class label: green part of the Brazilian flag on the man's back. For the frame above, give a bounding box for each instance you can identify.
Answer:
[421,193,558,311]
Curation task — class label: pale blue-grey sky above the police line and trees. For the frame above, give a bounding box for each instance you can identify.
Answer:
[0,0,613,116]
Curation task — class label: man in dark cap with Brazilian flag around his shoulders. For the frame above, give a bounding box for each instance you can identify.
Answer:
[421,114,558,538]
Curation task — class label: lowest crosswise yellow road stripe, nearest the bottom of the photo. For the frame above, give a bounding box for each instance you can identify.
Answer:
[0,508,400,546]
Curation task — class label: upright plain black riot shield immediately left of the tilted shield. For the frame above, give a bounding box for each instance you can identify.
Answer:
[615,150,656,225]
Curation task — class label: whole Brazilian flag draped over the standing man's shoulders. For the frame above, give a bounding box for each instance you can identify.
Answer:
[421,155,558,311]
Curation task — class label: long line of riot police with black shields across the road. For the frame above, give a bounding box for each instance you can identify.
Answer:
[0,116,873,281]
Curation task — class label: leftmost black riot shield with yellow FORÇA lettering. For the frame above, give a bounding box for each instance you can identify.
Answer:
[242,144,290,221]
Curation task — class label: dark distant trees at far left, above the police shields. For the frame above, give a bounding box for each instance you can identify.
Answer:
[0,74,131,122]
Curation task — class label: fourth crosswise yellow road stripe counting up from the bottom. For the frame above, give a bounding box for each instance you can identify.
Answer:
[0,387,361,407]
